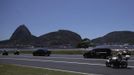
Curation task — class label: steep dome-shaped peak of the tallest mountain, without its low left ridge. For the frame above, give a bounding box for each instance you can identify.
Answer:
[10,25,36,45]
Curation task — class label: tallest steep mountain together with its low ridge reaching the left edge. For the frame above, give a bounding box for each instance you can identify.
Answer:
[0,25,36,47]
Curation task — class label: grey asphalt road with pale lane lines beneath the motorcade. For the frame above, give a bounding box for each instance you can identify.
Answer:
[0,55,134,75]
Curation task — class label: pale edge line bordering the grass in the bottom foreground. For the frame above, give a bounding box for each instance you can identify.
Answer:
[13,64,102,75]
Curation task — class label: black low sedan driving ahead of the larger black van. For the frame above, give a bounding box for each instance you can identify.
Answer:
[33,49,51,56]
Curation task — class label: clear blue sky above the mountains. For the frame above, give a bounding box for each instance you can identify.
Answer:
[0,0,134,40]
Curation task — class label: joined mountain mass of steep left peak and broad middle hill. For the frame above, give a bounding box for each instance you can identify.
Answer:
[0,25,81,48]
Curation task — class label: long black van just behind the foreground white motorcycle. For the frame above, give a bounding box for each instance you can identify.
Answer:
[83,48,112,59]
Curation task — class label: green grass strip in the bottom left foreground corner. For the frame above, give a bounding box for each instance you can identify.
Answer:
[0,64,86,75]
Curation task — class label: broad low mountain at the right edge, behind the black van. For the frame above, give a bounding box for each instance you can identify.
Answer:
[92,31,134,44]
